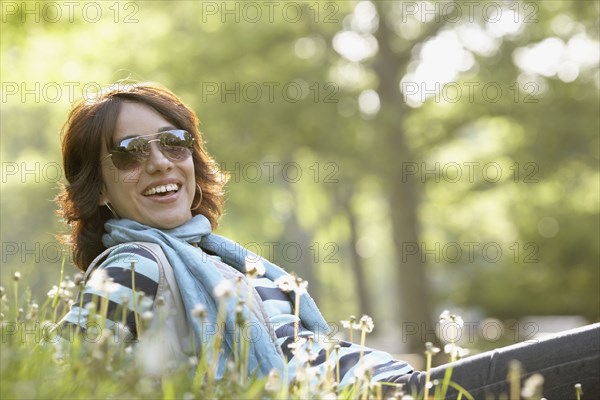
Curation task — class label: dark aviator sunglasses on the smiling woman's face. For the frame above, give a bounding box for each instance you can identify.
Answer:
[101,129,194,171]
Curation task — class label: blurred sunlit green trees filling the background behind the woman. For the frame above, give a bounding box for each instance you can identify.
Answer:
[0,0,600,360]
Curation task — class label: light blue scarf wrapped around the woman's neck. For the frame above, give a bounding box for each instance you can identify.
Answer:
[102,215,327,375]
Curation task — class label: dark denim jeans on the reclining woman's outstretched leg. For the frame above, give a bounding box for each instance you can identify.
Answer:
[393,324,600,400]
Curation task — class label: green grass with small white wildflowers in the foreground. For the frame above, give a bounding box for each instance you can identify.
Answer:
[0,272,579,400]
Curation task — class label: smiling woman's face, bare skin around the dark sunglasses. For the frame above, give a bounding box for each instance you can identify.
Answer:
[99,102,196,229]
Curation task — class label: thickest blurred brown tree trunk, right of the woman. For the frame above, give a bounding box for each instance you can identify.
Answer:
[373,3,439,353]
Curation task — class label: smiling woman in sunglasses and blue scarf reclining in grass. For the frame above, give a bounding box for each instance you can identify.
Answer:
[59,84,598,394]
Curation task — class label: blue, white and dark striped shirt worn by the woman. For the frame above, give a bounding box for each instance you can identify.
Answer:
[58,247,413,387]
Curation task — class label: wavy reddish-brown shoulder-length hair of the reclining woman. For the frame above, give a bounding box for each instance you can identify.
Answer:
[56,83,227,271]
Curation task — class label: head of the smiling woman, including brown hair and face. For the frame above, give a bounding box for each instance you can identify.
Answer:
[57,84,226,271]
